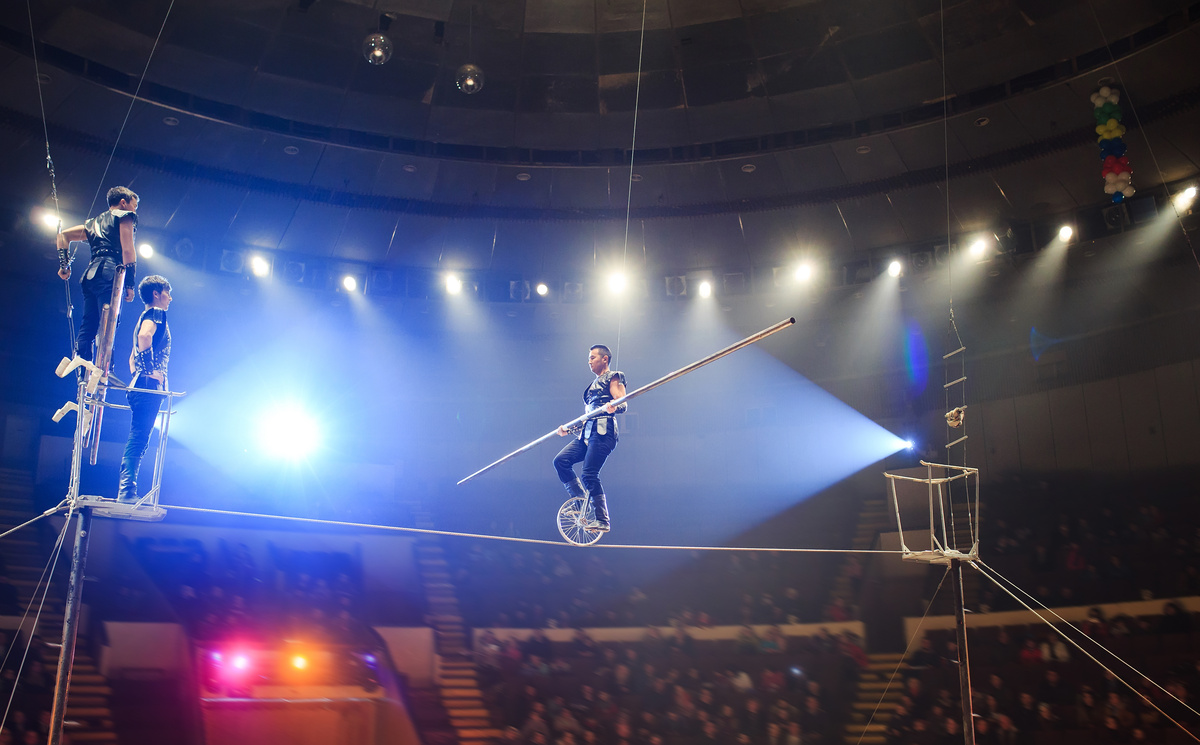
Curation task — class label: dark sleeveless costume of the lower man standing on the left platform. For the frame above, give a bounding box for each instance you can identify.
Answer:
[116,308,170,501]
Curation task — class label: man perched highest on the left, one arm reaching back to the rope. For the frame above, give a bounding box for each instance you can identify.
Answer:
[58,186,138,362]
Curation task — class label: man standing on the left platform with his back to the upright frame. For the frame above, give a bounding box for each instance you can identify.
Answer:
[116,275,172,503]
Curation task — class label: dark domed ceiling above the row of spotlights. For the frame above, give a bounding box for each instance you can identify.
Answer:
[0,0,1200,272]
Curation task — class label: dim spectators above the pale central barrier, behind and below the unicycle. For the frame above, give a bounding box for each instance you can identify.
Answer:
[451,543,851,629]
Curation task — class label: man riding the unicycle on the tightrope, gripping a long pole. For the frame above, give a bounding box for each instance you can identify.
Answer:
[554,344,628,531]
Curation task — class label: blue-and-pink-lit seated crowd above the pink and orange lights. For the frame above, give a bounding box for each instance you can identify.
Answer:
[134,539,367,644]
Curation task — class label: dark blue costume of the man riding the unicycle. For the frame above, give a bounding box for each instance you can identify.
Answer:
[554,370,626,529]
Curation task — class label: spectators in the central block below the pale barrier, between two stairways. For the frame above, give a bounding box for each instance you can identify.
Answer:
[475,625,865,745]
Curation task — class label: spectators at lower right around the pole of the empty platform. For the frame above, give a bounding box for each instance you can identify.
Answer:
[887,602,1200,745]
